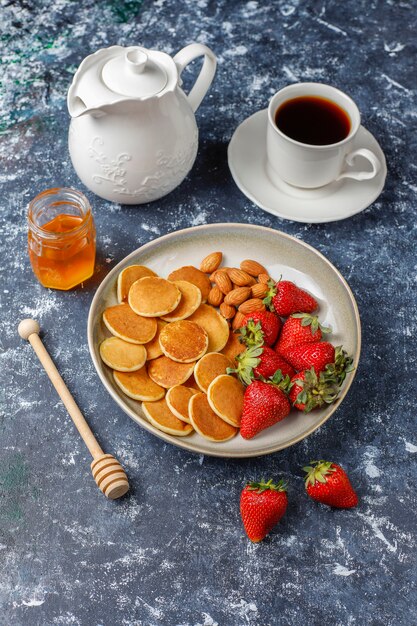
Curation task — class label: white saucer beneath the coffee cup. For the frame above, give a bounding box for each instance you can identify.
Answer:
[227,109,387,224]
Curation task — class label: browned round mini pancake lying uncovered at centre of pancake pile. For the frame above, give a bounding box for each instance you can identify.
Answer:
[159,320,208,363]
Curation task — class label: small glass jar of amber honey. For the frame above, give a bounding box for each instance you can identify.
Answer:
[28,187,96,290]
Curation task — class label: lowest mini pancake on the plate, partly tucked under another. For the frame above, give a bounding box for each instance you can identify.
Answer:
[188,393,238,442]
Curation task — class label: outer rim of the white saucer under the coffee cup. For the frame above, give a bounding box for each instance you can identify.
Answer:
[227,108,388,224]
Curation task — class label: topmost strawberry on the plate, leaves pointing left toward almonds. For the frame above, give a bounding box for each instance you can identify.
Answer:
[264,280,318,317]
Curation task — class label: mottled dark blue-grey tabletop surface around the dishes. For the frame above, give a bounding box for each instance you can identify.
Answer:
[0,0,417,626]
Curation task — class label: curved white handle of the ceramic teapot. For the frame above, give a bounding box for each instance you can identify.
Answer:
[174,43,217,113]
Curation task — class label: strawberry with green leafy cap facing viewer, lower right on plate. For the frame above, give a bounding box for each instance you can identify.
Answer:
[289,367,340,413]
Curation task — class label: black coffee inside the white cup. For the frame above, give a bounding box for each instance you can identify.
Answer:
[275,96,351,146]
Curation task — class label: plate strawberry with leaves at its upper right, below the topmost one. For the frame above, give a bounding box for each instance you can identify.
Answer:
[274,313,330,358]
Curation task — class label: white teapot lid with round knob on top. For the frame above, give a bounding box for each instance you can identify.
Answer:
[102,46,168,98]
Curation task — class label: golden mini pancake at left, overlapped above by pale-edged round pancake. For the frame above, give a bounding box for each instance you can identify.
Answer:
[103,304,157,344]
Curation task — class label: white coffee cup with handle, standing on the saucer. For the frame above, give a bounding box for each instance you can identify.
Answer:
[266,83,381,189]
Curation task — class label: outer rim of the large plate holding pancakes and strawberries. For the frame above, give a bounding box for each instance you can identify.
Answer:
[87,222,362,459]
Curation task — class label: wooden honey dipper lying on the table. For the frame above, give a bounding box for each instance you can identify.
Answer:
[18,319,129,500]
